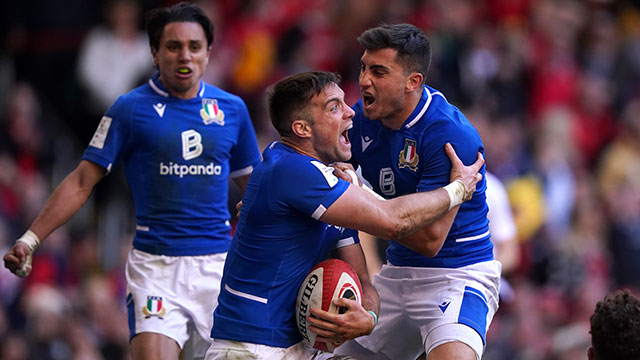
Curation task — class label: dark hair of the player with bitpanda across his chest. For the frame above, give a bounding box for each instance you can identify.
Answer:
[145,2,213,49]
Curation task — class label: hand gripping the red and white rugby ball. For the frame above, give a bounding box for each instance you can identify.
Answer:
[307,298,376,346]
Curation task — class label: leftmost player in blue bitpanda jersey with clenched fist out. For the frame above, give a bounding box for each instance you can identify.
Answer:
[4,3,261,360]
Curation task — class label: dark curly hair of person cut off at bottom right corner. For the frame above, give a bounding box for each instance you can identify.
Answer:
[589,290,640,360]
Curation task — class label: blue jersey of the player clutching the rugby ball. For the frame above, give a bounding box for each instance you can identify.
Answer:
[211,142,359,347]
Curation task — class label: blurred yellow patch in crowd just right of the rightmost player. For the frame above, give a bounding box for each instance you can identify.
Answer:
[507,175,546,242]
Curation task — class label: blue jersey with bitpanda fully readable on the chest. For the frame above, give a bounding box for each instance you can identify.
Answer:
[82,75,261,256]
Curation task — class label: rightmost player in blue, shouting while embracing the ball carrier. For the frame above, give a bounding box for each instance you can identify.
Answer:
[337,24,500,360]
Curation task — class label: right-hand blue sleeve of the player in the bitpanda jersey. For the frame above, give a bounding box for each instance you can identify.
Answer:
[229,99,261,178]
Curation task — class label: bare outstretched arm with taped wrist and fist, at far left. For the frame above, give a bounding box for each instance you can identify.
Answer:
[3,160,105,277]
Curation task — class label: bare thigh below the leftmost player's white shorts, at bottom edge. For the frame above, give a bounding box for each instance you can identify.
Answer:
[131,332,180,360]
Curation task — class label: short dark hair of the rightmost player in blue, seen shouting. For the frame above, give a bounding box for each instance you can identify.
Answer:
[358,24,431,83]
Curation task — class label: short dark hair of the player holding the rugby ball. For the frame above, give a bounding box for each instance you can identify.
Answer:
[267,71,342,136]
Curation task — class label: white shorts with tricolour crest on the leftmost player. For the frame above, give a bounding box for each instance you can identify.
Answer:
[126,249,227,357]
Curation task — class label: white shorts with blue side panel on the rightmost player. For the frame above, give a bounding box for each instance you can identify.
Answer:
[335,260,501,359]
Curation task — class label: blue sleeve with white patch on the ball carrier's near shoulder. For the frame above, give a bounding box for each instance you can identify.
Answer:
[270,157,349,220]
